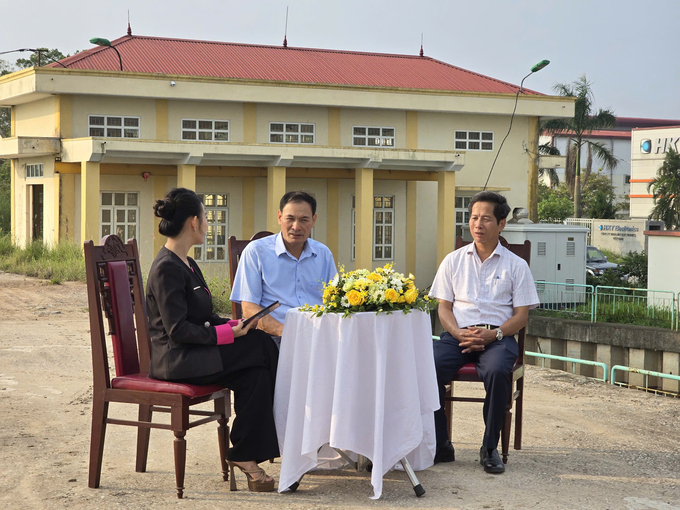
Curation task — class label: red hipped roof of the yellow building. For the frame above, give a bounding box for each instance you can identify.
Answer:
[49,35,539,94]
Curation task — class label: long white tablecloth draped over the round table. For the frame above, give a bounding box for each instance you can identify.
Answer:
[274,309,439,499]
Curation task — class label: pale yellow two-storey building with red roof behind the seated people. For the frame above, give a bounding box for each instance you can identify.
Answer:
[0,35,574,286]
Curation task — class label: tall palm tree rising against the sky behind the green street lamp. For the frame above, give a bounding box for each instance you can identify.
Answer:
[541,74,619,218]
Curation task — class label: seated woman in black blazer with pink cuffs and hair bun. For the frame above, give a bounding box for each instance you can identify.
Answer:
[146,188,279,492]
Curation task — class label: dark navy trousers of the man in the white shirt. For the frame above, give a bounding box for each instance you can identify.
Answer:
[434,332,519,449]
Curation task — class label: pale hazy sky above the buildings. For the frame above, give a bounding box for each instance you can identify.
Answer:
[0,0,680,119]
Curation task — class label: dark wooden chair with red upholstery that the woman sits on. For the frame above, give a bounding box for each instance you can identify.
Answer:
[85,235,231,498]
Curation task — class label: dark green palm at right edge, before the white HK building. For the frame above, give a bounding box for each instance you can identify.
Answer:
[647,149,680,230]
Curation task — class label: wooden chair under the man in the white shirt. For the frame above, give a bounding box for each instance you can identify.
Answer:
[444,236,531,464]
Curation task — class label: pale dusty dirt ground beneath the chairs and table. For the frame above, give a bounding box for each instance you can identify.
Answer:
[0,273,680,510]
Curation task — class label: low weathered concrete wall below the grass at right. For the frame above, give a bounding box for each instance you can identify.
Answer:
[525,316,680,393]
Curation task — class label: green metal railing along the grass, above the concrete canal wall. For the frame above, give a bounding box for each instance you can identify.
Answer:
[532,281,680,330]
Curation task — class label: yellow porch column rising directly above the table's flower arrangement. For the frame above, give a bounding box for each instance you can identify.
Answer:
[354,168,373,270]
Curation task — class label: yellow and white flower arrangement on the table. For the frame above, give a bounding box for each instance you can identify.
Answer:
[300,263,436,317]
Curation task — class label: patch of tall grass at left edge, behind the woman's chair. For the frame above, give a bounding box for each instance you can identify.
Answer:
[0,235,85,285]
